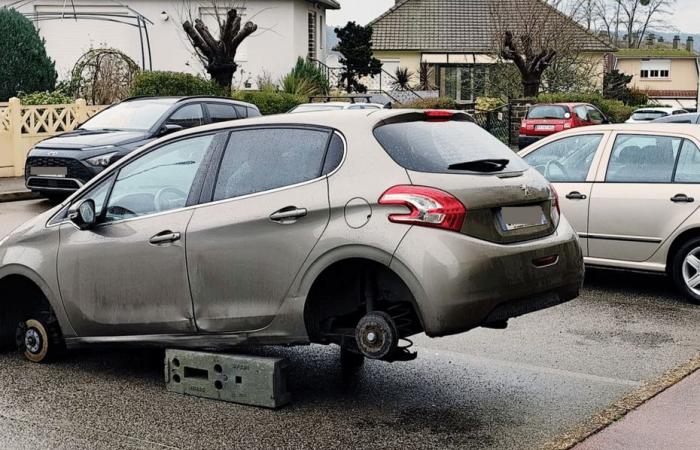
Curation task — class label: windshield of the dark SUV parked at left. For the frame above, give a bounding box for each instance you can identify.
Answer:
[80,100,175,131]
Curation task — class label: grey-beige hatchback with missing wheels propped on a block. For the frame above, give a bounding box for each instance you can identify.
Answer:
[0,110,584,367]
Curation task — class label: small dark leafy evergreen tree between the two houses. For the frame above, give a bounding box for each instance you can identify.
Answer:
[333,22,382,93]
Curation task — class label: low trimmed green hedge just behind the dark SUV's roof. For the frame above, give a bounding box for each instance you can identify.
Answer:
[129,72,226,97]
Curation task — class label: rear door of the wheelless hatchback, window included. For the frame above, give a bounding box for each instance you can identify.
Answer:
[187,127,342,332]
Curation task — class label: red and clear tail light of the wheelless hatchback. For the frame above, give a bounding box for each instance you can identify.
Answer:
[379,185,467,231]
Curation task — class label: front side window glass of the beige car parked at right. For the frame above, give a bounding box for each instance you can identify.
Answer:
[524,134,603,183]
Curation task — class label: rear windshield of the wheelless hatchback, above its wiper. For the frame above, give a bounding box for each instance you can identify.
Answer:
[374,120,528,173]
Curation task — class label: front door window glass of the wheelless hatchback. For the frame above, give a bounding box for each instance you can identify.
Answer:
[104,135,214,222]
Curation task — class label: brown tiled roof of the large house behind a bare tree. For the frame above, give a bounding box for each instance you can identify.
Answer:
[370,0,614,53]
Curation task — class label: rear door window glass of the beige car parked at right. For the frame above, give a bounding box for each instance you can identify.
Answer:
[605,134,682,183]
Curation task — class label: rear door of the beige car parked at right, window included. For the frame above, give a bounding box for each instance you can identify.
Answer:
[588,132,700,262]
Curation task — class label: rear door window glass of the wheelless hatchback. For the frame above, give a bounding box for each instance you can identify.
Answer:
[214,128,329,201]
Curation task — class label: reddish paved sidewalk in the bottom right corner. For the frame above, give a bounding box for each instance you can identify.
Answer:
[574,371,700,450]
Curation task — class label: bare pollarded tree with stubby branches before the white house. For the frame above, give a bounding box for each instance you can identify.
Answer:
[182,3,258,90]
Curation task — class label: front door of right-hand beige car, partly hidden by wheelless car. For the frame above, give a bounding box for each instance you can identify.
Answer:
[523,133,606,255]
